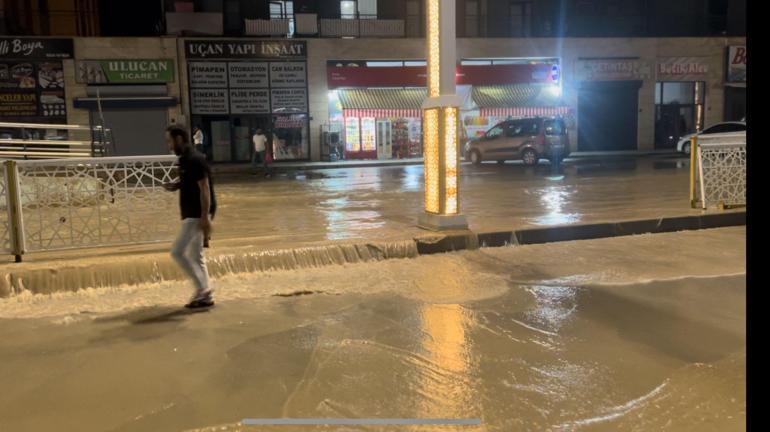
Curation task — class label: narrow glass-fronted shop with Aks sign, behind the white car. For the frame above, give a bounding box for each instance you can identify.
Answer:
[655,57,709,149]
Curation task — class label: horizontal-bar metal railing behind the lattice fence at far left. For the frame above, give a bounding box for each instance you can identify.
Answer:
[0,122,113,159]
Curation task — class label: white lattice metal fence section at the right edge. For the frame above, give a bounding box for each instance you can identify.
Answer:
[693,132,746,209]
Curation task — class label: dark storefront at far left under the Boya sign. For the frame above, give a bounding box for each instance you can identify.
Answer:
[0,37,74,128]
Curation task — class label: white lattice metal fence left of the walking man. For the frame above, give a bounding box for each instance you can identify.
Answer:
[0,156,177,257]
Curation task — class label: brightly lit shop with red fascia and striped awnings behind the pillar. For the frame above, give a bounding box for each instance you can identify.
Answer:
[327,59,569,159]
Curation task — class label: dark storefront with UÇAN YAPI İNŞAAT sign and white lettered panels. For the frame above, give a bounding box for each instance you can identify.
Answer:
[184,39,310,162]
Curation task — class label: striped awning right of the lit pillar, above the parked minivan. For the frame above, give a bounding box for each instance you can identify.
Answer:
[464,84,569,117]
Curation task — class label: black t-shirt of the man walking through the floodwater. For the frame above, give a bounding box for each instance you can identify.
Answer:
[178,149,217,223]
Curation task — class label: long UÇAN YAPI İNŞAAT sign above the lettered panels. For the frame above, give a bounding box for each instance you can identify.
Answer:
[185,39,307,59]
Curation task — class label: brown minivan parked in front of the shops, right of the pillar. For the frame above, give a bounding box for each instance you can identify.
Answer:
[465,117,569,165]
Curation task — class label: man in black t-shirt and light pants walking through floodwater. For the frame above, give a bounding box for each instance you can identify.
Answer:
[163,125,217,309]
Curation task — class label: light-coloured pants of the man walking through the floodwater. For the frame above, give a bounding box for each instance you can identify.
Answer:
[171,218,211,299]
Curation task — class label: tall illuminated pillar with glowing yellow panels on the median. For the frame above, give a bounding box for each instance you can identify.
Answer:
[418,0,468,230]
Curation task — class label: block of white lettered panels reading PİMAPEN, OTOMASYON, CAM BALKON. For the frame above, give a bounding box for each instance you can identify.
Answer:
[188,61,308,114]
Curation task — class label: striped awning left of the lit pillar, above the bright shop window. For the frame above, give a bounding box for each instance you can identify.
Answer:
[338,88,426,117]
